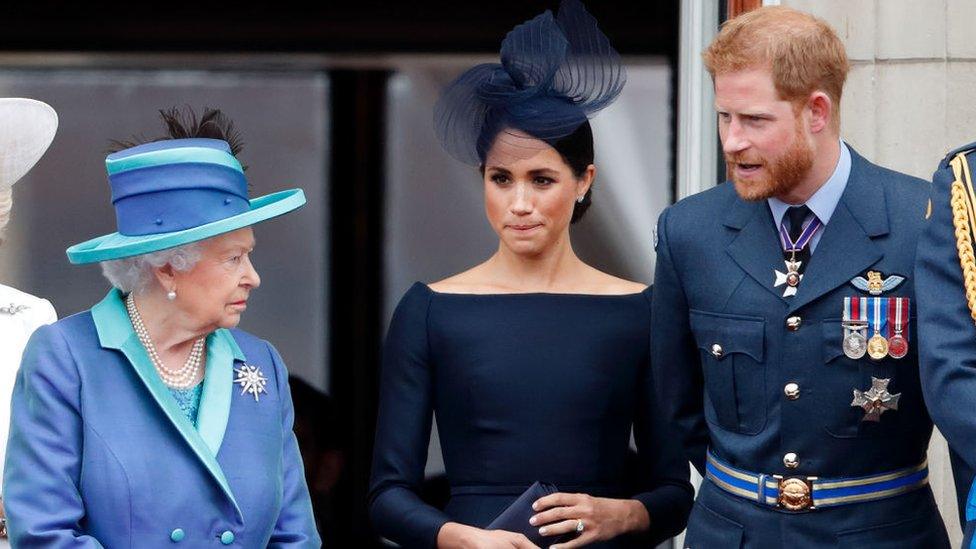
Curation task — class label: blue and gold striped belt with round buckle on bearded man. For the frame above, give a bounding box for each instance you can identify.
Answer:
[705,452,929,511]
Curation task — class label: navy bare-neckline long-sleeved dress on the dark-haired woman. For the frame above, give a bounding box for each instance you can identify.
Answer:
[369,283,693,548]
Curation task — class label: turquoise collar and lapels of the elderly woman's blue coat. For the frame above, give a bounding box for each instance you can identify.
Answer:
[91,289,245,513]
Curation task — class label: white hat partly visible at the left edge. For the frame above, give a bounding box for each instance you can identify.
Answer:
[0,97,58,190]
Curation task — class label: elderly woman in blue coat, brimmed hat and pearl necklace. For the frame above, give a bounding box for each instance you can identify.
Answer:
[4,110,321,548]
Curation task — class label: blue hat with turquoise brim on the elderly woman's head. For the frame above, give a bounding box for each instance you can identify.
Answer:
[67,139,305,264]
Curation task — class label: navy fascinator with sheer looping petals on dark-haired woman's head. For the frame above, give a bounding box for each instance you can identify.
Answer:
[434,0,627,166]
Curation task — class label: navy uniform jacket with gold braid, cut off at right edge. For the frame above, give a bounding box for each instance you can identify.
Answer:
[915,143,976,538]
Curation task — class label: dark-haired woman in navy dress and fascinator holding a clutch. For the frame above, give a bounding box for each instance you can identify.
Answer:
[369,0,693,549]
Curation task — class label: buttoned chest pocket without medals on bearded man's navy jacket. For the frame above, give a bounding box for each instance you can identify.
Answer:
[690,310,766,435]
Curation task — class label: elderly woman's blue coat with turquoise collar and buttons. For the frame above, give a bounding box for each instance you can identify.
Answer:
[4,290,321,549]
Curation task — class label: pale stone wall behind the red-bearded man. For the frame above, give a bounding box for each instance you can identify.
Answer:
[781,0,976,546]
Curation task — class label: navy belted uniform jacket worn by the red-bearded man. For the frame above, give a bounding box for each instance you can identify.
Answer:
[652,150,948,548]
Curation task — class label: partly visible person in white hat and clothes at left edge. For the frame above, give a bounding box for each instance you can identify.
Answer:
[0,98,58,549]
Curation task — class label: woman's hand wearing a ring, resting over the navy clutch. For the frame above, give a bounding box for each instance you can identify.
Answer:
[529,493,651,549]
